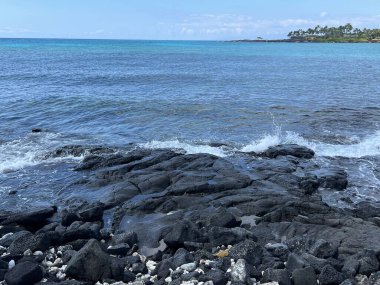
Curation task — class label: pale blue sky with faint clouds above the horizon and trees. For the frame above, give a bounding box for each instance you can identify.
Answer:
[0,0,380,40]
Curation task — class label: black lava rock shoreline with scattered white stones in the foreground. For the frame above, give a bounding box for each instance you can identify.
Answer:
[0,145,380,285]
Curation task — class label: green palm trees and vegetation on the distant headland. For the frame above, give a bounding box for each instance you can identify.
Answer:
[288,24,380,43]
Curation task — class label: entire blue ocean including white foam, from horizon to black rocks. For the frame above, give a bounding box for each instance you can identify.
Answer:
[0,39,380,210]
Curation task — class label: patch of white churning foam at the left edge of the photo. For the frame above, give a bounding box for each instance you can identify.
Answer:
[0,133,84,173]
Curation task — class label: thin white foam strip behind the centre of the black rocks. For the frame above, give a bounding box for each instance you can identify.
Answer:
[139,140,229,157]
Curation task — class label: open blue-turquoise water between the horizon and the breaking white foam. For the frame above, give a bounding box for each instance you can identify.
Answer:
[0,39,380,144]
